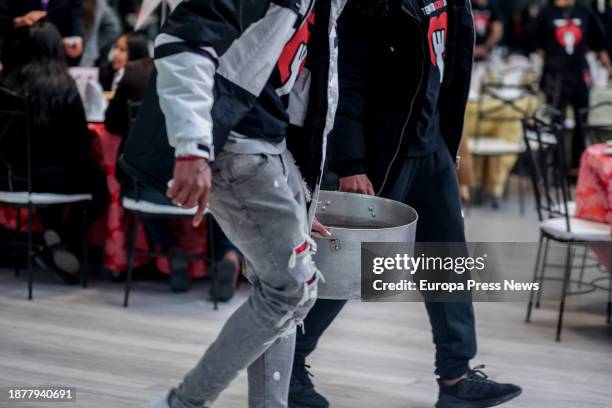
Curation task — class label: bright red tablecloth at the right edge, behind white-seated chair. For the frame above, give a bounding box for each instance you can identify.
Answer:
[576,144,612,225]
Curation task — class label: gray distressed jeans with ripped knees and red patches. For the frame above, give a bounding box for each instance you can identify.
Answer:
[168,151,318,408]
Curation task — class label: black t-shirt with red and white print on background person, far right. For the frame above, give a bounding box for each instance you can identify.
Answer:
[526,4,606,86]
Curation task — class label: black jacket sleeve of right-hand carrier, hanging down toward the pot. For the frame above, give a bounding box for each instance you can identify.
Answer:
[329,7,369,177]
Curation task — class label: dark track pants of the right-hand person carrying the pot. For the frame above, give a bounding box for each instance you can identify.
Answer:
[294,147,476,379]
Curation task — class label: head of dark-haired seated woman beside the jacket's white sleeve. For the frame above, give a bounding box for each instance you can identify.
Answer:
[100,32,151,92]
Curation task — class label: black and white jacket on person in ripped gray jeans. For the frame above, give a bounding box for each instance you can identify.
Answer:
[120,0,347,191]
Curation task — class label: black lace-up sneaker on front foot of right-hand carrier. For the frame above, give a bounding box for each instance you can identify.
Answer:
[436,366,522,408]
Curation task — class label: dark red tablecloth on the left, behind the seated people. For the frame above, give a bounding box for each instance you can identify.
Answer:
[0,124,207,277]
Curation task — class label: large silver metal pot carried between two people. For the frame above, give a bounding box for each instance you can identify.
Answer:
[314,191,418,300]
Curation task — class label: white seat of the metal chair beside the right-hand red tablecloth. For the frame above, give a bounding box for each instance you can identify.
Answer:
[540,217,612,241]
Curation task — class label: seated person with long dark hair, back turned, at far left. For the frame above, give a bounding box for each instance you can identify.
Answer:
[0,23,105,283]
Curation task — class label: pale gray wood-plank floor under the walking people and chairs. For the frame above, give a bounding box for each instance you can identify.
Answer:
[0,196,612,408]
